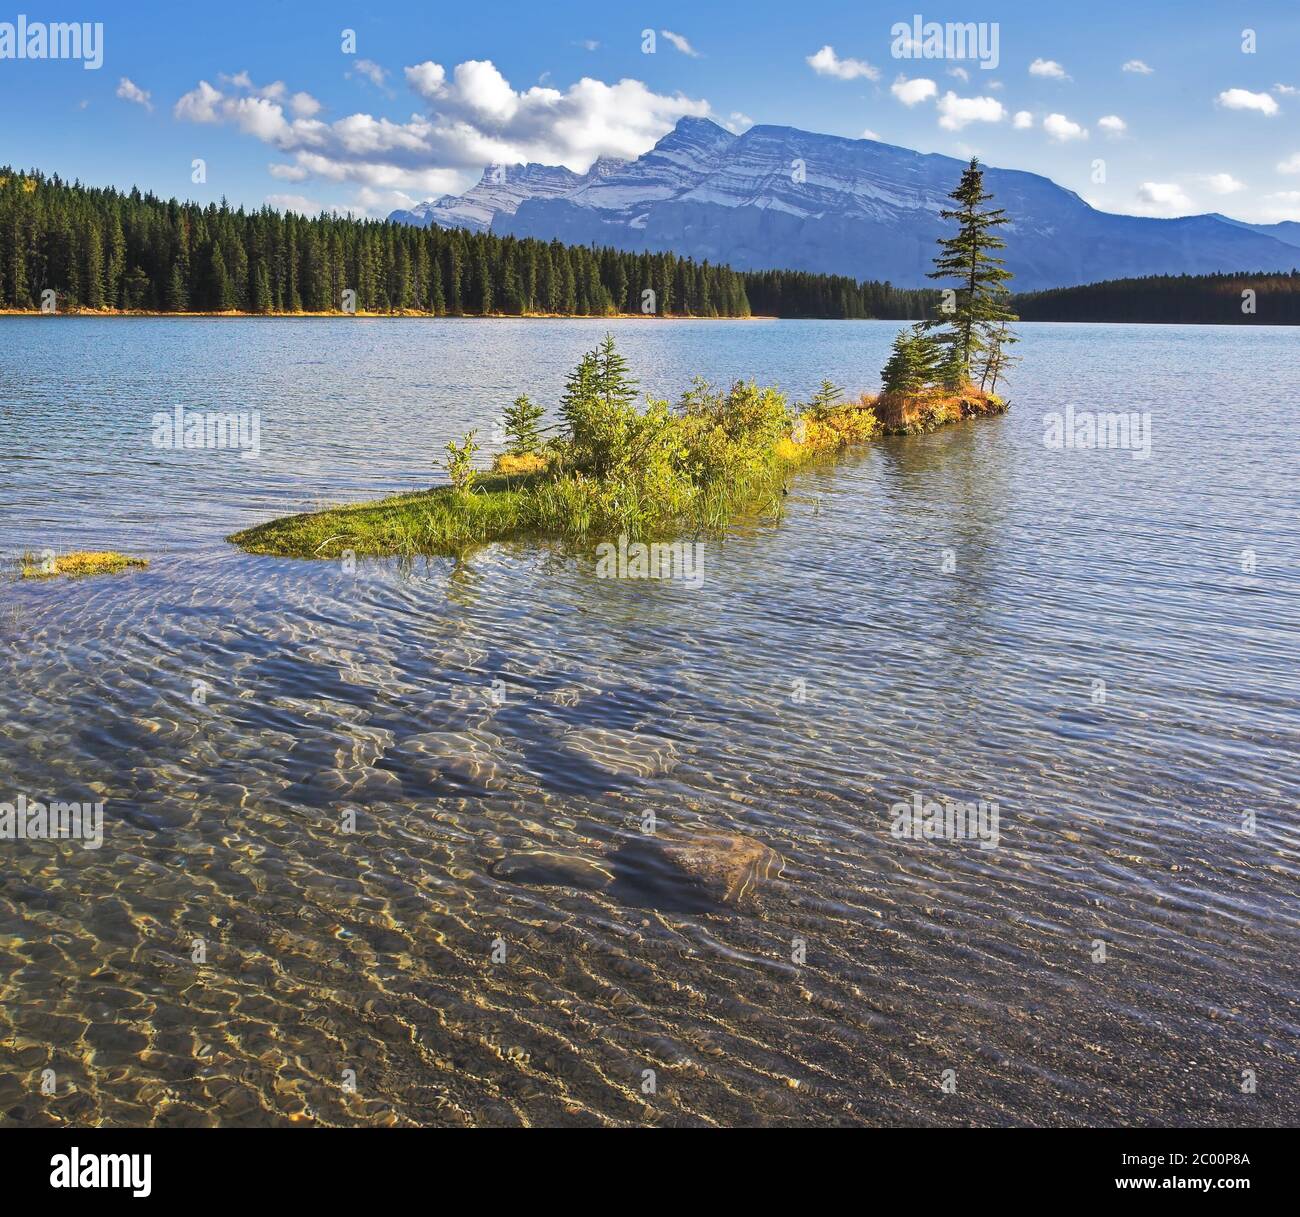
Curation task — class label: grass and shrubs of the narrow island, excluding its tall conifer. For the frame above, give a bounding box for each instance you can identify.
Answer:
[230,337,1006,558]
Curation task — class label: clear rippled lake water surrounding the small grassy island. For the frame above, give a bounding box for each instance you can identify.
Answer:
[0,319,1300,1125]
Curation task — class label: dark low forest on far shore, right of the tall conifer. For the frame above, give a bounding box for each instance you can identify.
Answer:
[1015,270,1300,325]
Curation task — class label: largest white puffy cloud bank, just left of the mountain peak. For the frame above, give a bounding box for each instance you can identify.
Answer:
[174,60,712,206]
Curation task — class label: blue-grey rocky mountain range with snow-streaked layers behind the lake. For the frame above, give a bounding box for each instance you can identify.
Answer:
[389,118,1300,291]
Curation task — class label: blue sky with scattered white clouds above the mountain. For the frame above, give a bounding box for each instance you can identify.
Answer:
[0,0,1300,221]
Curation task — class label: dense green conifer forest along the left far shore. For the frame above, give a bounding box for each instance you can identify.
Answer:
[0,168,937,319]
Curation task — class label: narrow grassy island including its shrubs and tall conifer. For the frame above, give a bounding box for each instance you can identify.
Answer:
[229,160,1015,558]
